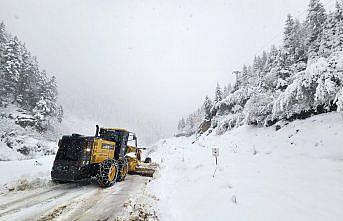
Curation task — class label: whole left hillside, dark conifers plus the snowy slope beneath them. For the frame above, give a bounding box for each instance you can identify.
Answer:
[0,22,63,160]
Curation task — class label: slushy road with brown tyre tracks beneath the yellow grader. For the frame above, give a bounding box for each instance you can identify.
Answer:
[0,176,149,221]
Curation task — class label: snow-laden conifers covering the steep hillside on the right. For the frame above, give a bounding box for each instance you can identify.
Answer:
[178,0,343,135]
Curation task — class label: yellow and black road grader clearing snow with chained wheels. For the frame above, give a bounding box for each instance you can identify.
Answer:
[51,125,154,187]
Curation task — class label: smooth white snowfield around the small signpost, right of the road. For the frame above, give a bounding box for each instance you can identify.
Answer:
[150,113,343,221]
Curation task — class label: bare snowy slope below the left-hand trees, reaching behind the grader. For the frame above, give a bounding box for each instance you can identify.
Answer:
[0,105,96,161]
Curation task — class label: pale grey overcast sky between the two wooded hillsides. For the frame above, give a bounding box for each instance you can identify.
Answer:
[0,0,333,144]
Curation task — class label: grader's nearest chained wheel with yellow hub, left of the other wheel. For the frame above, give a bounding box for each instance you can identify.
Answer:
[96,160,118,187]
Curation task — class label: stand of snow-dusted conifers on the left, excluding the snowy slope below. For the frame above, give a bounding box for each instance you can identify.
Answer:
[0,22,63,131]
